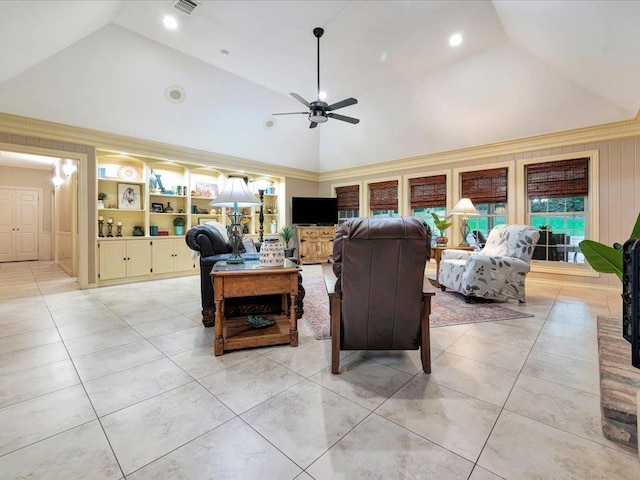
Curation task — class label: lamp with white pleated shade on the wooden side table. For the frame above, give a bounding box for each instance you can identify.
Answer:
[209,175,261,263]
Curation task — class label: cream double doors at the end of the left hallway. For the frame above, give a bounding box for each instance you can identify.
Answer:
[0,189,39,262]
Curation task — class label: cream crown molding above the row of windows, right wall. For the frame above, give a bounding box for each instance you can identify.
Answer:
[319,110,640,182]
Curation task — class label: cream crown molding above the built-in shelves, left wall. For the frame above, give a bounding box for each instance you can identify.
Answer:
[0,112,318,182]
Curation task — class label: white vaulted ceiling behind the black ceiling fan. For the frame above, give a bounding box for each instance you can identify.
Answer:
[0,0,640,171]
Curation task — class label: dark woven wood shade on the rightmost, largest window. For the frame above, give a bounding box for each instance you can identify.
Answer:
[527,158,589,198]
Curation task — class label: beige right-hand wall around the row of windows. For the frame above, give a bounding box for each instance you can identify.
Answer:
[319,136,640,286]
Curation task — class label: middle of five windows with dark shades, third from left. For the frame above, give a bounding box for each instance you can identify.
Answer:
[409,175,447,245]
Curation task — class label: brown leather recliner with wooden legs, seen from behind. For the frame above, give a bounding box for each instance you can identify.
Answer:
[329,217,435,373]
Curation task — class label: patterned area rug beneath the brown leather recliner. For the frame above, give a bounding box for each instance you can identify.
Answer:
[302,277,533,340]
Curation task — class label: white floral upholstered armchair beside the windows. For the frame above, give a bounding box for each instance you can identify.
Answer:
[439,225,540,303]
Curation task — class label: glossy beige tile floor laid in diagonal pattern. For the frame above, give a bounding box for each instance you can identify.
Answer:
[0,262,640,480]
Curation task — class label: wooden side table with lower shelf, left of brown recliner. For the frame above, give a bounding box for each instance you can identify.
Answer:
[211,259,301,355]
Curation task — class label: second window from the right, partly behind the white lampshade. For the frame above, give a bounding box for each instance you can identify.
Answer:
[460,167,508,238]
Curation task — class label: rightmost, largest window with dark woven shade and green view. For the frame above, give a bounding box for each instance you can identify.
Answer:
[526,158,589,264]
